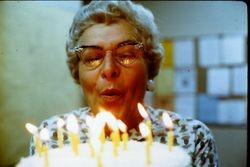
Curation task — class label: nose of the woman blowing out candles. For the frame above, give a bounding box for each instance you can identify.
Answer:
[101,51,120,80]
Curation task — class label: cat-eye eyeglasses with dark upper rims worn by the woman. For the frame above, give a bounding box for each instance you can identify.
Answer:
[75,40,144,70]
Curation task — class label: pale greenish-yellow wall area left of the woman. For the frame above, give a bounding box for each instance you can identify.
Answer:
[0,1,82,166]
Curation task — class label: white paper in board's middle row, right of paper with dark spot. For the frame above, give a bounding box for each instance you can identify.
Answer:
[207,67,230,96]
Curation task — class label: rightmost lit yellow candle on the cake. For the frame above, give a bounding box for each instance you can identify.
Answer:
[162,112,174,151]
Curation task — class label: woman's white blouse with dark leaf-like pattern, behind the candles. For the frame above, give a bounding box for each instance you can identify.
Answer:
[30,106,219,167]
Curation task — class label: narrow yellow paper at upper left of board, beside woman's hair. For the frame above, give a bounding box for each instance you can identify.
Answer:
[162,39,173,68]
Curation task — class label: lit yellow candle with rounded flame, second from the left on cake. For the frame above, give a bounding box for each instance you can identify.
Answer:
[40,128,49,167]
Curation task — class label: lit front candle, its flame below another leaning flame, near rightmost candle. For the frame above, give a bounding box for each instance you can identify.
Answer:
[139,122,151,164]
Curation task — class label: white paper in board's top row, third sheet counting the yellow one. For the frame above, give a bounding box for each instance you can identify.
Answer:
[198,36,220,67]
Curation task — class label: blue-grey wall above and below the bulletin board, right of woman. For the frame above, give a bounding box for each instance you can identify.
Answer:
[140,1,248,167]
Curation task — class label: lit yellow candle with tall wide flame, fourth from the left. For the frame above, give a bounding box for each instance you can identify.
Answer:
[66,114,80,155]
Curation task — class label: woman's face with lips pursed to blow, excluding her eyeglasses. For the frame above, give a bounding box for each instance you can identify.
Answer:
[78,20,148,126]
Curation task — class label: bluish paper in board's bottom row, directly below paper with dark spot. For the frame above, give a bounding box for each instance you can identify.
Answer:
[174,94,196,118]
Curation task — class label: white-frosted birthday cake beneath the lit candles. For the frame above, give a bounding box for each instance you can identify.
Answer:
[16,140,191,167]
